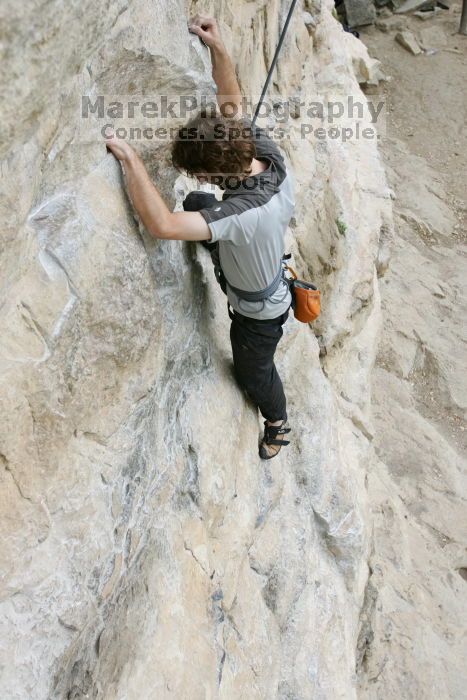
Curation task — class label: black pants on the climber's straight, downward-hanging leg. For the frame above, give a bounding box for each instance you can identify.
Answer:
[230,310,289,421]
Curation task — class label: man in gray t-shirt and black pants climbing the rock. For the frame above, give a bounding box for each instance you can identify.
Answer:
[106,15,294,459]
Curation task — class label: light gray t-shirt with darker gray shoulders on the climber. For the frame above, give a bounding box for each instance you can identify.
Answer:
[200,119,295,319]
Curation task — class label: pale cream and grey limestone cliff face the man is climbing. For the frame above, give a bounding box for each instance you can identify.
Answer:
[0,0,392,700]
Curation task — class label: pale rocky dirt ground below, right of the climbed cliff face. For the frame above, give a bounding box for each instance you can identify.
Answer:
[360,5,467,700]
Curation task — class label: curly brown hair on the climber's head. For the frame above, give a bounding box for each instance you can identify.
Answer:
[172,113,256,177]
